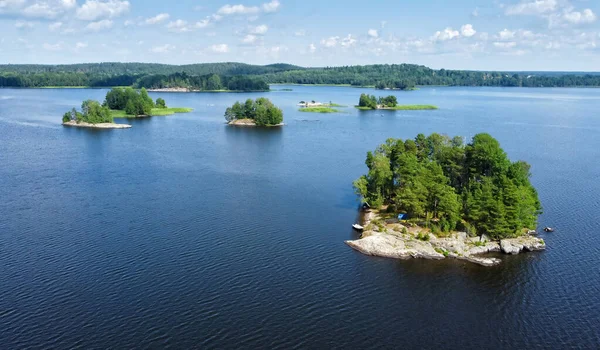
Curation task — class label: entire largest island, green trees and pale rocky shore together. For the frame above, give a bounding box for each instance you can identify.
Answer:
[346,133,546,266]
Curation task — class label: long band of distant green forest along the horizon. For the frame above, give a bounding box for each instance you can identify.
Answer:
[0,63,600,91]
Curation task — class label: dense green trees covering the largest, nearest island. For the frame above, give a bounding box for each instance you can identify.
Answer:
[354,133,542,239]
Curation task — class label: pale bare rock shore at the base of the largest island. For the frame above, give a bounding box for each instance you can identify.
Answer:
[346,211,546,266]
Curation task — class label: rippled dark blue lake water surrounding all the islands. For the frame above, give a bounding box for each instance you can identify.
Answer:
[0,86,600,349]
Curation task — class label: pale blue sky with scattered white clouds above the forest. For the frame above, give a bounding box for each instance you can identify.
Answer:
[0,0,600,71]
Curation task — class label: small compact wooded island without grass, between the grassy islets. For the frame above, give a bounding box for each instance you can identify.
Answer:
[225,97,283,126]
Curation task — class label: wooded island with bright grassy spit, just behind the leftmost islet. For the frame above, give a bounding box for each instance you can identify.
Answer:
[103,87,192,118]
